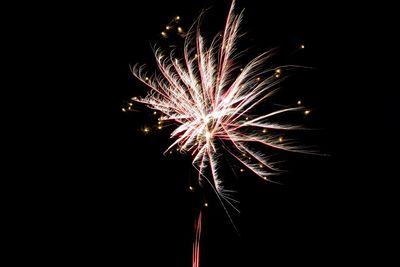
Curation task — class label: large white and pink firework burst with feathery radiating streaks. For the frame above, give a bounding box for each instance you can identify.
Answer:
[132,2,303,224]
